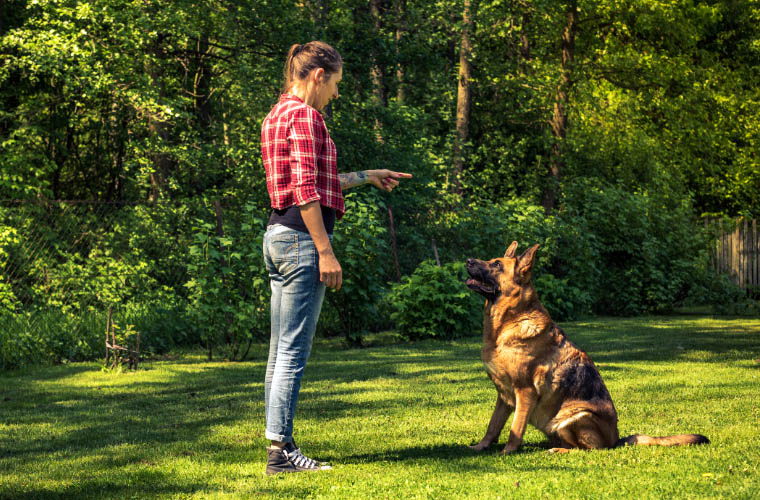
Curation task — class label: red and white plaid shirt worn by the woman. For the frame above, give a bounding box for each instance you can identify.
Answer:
[261,94,346,219]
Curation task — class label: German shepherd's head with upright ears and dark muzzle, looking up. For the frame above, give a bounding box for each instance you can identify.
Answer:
[467,241,538,303]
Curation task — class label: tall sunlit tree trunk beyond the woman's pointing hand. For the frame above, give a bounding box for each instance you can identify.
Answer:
[452,0,474,193]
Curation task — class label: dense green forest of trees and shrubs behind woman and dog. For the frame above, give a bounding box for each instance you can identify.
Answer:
[0,0,760,369]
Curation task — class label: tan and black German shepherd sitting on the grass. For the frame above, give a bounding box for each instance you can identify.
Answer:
[467,241,710,454]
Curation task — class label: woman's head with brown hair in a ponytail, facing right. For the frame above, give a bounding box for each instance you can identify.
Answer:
[283,41,343,109]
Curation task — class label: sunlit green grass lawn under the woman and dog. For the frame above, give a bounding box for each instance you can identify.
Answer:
[0,316,760,499]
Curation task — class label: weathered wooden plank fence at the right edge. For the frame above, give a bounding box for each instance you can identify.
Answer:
[705,219,760,290]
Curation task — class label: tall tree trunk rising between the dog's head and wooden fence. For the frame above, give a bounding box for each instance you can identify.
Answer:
[541,0,578,213]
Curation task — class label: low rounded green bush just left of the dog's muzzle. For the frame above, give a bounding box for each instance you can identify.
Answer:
[385,260,483,340]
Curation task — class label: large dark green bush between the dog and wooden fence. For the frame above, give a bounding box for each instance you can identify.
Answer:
[561,178,720,315]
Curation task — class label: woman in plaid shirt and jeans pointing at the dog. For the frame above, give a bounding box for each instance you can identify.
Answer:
[261,41,411,474]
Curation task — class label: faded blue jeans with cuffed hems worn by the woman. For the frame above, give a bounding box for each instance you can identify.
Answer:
[264,224,325,443]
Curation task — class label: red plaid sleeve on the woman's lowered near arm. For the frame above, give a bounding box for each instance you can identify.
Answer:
[288,106,325,206]
